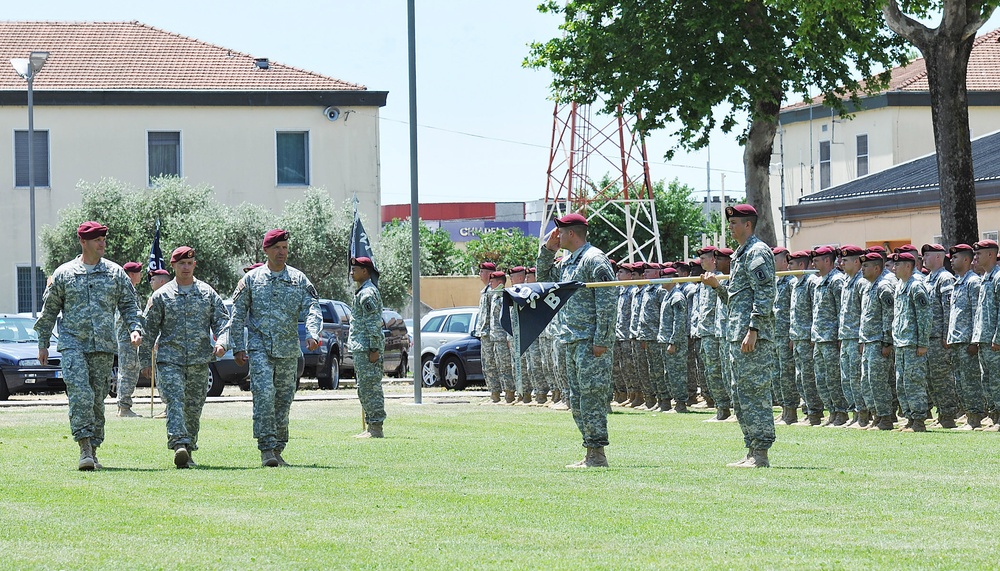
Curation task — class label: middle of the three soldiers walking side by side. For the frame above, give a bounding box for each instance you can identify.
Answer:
[141,246,229,468]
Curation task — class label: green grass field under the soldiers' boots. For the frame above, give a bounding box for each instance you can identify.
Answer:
[0,388,1000,570]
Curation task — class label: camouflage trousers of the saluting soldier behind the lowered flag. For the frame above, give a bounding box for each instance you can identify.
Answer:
[563,341,614,448]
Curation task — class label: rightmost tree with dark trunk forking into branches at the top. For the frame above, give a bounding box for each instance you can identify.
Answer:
[884,0,1000,246]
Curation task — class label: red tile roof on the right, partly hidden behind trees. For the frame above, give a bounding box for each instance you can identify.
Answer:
[781,28,1000,111]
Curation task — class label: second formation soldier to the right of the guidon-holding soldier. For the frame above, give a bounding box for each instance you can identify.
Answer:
[788,250,823,426]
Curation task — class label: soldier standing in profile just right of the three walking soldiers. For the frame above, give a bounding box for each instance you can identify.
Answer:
[347,256,385,438]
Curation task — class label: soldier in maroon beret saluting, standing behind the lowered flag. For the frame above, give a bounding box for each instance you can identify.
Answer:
[535,213,615,468]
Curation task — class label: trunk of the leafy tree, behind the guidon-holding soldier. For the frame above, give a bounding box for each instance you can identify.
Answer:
[744,95,784,247]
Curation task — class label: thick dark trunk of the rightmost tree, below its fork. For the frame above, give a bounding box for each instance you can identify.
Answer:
[923,37,979,247]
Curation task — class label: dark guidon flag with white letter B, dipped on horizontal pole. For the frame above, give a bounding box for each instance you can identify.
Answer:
[500,282,585,356]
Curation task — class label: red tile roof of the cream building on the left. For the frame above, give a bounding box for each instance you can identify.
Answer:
[0,22,366,91]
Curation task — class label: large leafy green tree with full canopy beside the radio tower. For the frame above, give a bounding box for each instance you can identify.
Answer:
[525,0,923,244]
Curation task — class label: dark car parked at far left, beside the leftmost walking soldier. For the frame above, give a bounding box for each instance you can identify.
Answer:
[0,314,66,400]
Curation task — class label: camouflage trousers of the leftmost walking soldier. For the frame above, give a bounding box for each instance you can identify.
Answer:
[60,349,115,447]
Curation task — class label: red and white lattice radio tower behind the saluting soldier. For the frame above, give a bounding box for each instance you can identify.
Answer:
[541,103,662,262]
